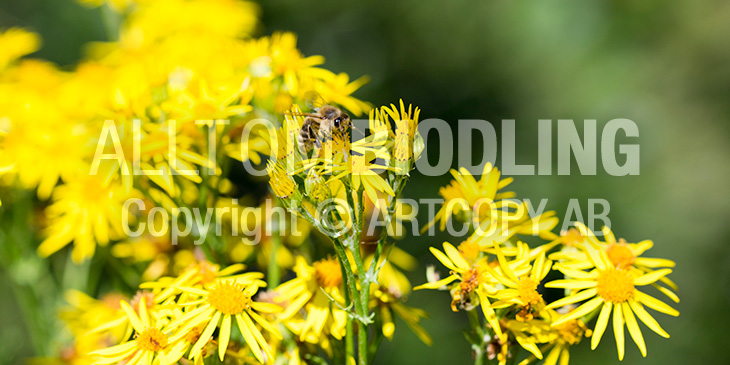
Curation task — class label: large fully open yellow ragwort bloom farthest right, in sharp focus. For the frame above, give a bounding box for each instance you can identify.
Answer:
[545,245,679,360]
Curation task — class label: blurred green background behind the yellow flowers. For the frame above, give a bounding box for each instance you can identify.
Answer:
[0,0,730,364]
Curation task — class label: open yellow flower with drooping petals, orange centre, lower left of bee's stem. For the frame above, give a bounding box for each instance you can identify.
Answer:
[167,279,281,363]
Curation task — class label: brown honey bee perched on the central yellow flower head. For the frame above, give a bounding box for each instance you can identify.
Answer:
[292,92,352,153]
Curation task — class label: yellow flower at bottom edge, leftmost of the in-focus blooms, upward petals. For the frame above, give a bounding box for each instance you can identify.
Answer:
[91,301,182,365]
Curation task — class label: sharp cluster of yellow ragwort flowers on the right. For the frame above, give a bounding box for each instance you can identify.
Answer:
[416,171,679,365]
